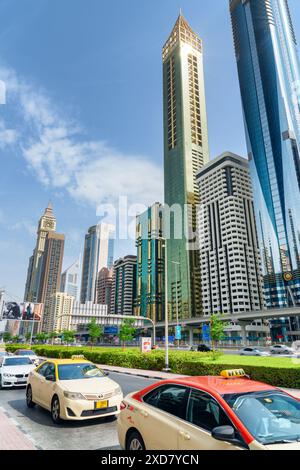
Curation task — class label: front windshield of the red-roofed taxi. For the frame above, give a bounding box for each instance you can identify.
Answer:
[223,391,300,444]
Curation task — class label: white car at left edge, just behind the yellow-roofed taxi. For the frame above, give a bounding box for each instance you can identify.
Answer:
[0,356,36,389]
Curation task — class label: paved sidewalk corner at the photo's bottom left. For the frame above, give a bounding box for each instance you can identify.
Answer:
[0,408,36,450]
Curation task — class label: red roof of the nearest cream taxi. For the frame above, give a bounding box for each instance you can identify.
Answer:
[157,376,276,395]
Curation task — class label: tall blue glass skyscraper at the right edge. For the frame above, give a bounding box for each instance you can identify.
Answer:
[230,0,300,308]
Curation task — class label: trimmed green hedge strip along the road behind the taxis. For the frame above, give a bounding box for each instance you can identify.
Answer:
[6,344,300,388]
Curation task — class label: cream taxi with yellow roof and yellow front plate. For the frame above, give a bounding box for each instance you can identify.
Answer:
[26,356,123,423]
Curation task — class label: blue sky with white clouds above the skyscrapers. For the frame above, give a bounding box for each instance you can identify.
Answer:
[0,0,300,300]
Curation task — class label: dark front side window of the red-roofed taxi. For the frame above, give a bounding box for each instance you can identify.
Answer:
[187,390,232,431]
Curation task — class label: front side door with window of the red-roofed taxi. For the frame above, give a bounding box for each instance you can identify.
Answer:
[178,389,244,450]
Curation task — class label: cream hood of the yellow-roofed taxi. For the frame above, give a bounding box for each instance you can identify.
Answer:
[59,377,119,394]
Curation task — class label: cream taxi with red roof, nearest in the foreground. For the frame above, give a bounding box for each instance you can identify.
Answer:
[118,370,300,450]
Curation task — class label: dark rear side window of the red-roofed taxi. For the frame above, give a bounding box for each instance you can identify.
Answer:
[144,385,189,419]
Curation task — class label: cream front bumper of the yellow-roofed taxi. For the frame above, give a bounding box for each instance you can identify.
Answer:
[61,395,123,421]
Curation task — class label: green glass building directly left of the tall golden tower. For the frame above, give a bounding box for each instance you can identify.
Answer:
[135,202,164,322]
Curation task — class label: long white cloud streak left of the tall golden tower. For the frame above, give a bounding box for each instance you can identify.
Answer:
[0,64,163,207]
